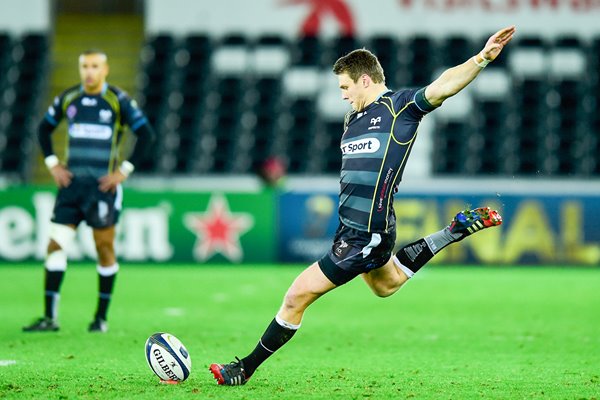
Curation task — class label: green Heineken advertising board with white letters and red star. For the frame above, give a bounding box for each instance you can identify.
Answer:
[0,187,276,263]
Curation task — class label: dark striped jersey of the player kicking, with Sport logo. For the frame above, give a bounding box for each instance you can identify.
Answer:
[339,88,435,232]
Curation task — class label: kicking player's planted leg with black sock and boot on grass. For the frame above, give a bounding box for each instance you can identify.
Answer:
[209,263,336,386]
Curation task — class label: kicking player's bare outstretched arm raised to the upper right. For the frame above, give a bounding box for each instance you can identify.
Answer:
[425,26,516,107]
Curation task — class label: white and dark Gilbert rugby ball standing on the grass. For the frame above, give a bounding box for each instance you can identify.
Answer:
[146,332,192,383]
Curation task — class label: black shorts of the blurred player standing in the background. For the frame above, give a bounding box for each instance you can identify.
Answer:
[52,177,123,228]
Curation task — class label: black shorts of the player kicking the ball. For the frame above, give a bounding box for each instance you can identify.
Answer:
[319,222,396,286]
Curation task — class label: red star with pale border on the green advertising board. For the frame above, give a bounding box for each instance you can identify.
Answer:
[183,195,254,262]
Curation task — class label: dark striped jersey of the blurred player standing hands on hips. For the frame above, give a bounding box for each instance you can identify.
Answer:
[40,83,148,179]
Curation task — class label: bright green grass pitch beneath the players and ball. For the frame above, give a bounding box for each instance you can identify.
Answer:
[0,264,600,399]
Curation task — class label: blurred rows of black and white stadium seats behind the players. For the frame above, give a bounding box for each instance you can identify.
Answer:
[0,32,600,177]
